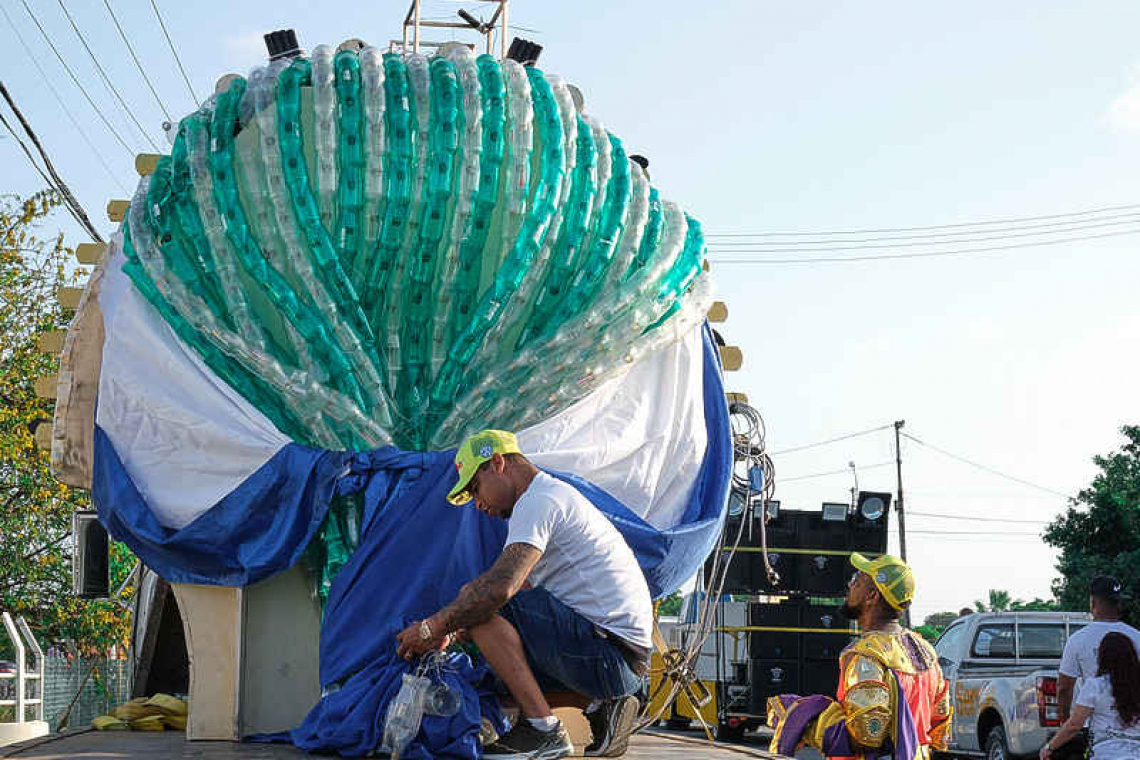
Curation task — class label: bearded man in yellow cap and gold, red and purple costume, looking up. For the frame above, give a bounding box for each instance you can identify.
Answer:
[768,554,953,760]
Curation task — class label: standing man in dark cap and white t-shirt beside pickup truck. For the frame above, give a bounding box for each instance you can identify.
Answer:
[1057,575,1140,724]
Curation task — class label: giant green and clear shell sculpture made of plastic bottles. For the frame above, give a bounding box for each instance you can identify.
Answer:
[123,46,710,458]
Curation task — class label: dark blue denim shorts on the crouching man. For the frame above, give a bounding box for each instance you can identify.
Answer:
[499,588,642,700]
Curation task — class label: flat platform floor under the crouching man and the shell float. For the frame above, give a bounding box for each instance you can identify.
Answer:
[0,729,793,760]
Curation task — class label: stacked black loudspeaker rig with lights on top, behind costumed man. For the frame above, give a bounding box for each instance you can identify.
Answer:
[706,491,890,725]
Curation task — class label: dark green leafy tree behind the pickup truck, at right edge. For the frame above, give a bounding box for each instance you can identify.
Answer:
[1044,425,1140,626]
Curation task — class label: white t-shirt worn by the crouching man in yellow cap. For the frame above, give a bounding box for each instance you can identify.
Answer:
[506,473,653,648]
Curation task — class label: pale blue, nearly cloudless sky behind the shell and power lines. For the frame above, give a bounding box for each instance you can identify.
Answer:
[0,0,1140,616]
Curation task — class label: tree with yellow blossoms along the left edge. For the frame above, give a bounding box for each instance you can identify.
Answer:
[0,191,133,653]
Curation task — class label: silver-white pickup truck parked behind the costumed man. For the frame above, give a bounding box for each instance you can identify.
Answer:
[935,612,1090,760]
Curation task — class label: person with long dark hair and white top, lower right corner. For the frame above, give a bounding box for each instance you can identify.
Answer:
[1040,631,1140,760]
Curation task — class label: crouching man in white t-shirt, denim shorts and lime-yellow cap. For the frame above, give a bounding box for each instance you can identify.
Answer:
[397,431,653,760]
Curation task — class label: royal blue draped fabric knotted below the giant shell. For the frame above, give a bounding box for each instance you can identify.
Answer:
[92,330,732,758]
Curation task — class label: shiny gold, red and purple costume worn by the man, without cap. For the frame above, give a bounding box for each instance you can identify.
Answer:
[768,629,953,760]
